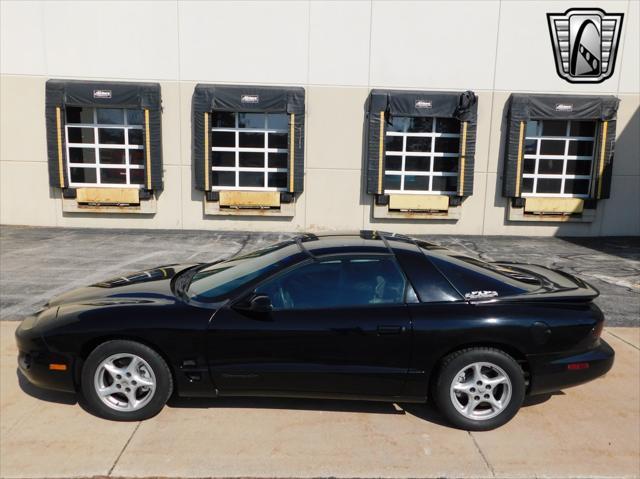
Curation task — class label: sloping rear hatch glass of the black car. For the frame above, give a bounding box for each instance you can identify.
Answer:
[429,253,540,296]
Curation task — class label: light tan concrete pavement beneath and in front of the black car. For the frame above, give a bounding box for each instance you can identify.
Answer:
[0,321,640,479]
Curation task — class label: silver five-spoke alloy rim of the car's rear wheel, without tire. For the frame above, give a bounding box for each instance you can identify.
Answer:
[450,362,512,421]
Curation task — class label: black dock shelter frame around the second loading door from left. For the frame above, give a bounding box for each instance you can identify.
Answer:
[192,84,305,193]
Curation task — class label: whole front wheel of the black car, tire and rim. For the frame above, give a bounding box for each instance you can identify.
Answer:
[81,340,173,421]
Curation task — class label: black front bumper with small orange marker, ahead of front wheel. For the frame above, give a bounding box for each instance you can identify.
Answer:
[15,317,76,392]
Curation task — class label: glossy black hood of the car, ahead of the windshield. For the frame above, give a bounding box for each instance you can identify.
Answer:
[47,264,197,307]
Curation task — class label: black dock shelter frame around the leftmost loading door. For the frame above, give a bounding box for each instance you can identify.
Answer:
[45,80,162,190]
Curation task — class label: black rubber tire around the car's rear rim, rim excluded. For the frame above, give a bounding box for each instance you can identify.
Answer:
[432,347,525,431]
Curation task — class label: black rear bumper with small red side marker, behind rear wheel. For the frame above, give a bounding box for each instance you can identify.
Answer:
[529,340,615,394]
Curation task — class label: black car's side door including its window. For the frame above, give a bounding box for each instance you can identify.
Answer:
[208,255,413,397]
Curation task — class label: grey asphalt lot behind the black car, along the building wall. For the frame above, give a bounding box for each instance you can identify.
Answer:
[0,226,640,326]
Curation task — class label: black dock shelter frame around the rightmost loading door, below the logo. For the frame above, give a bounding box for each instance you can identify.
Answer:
[503,93,620,199]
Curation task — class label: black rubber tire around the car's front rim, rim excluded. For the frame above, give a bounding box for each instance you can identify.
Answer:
[80,340,173,421]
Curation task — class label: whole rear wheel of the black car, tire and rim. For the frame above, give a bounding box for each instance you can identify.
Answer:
[434,348,525,431]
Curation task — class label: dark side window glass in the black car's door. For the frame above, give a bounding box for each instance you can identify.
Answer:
[256,256,407,310]
